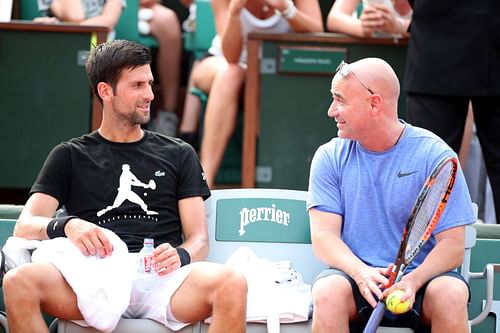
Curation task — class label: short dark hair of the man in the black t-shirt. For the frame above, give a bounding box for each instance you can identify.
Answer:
[86,39,151,104]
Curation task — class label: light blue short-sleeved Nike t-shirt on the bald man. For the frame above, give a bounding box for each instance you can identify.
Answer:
[307,124,475,270]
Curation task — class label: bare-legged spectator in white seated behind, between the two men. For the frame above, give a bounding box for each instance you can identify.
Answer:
[181,0,323,187]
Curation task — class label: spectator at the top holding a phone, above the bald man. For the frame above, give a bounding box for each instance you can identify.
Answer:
[326,0,412,38]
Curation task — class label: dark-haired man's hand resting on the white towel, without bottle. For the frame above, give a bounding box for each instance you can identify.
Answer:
[64,218,113,258]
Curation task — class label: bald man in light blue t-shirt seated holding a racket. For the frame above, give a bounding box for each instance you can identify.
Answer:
[307,58,475,333]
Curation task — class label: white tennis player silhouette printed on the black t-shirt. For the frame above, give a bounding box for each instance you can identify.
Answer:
[97,164,158,216]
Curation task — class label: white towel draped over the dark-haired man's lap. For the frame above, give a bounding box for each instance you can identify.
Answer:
[3,230,137,332]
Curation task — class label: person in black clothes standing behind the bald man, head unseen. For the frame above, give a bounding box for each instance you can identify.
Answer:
[405,0,500,223]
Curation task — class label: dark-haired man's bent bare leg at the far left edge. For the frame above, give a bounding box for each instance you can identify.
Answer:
[3,263,83,332]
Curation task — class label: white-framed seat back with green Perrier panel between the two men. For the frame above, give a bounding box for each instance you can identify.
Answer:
[205,188,325,283]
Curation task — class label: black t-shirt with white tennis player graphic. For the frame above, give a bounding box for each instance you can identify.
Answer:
[31,131,210,252]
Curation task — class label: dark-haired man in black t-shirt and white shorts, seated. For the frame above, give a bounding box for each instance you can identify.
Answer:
[3,40,247,333]
